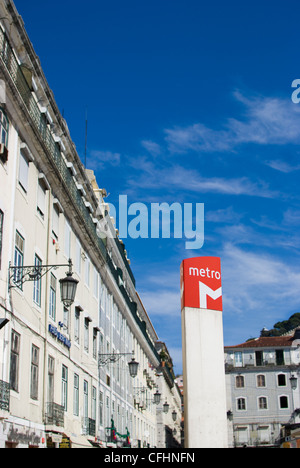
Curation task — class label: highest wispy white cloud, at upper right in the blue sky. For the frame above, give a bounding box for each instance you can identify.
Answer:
[165,91,300,153]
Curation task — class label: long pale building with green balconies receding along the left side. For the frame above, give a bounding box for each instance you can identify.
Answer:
[0,0,180,448]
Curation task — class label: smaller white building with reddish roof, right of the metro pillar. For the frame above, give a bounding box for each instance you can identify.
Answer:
[225,329,300,447]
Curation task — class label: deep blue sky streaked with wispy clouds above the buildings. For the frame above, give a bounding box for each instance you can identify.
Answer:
[15,0,300,372]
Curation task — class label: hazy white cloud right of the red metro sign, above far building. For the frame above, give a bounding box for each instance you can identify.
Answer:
[221,243,300,318]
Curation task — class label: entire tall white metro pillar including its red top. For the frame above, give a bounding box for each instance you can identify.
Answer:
[180,257,228,448]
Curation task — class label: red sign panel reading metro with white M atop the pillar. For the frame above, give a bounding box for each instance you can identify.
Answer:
[180,257,223,312]
